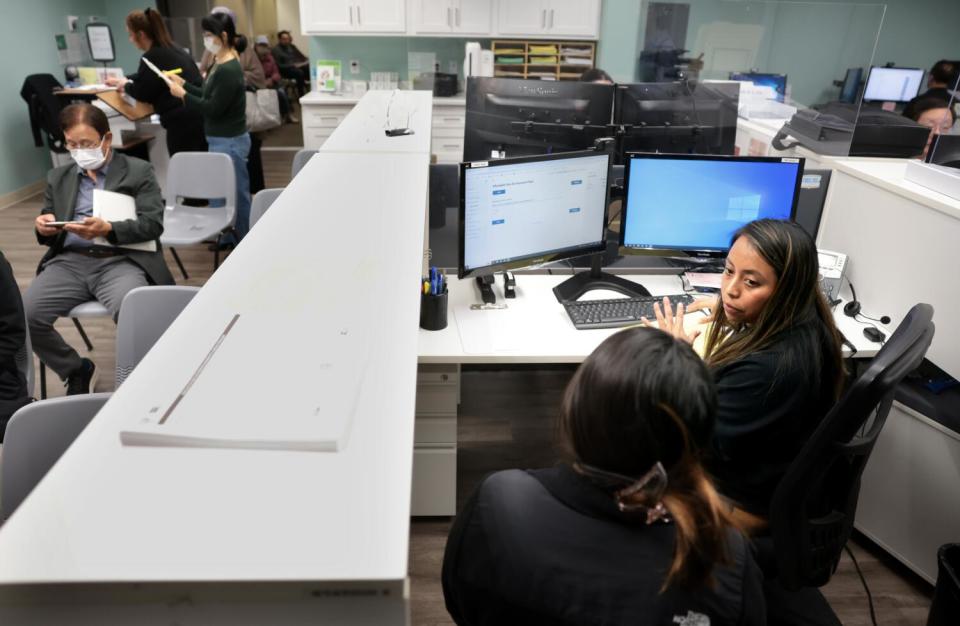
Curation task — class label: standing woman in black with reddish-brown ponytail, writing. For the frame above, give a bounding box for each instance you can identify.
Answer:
[107,8,207,156]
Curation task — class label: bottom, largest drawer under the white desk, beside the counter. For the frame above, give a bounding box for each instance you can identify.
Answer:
[410,446,457,515]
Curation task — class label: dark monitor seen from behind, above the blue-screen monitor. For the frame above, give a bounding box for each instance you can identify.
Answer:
[614,81,740,154]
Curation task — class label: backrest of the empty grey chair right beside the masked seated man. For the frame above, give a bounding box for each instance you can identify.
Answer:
[165,152,237,216]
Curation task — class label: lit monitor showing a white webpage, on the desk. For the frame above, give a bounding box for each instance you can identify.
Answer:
[457,151,610,278]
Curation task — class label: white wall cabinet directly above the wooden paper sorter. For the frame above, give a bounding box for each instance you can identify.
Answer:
[497,0,600,39]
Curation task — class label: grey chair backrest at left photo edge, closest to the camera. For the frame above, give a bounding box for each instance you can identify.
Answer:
[0,393,111,520]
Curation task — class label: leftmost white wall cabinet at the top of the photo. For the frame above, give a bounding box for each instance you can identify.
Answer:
[300,0,406,35]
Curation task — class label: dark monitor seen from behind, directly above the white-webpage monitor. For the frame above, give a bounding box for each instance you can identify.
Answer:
[463,77,614,161]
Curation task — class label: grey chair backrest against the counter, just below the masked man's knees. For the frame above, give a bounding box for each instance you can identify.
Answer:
[116,285,200,387]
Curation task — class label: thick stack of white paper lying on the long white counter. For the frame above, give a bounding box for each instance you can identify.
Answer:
[120,312,373,452]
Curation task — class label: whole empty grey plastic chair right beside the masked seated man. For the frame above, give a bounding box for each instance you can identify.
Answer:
[160,152,237,279]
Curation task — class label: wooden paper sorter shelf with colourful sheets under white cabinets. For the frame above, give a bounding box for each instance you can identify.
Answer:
[492,39,597,80]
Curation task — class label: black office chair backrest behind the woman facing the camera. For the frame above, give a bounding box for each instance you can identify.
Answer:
[770,304,934,590]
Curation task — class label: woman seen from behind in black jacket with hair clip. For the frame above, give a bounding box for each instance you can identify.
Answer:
[443,328,765,626]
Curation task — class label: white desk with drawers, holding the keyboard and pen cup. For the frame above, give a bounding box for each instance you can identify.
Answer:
[413,272,876,515]
